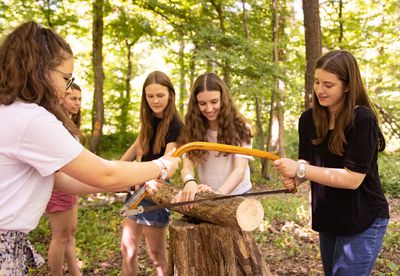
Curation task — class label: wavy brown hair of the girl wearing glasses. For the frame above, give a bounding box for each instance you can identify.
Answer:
[0,21,79,135]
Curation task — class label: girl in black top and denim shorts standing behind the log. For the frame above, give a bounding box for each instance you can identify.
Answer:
[121,71,183,275]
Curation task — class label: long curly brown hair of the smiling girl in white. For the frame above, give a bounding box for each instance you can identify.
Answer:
[180,73,253,161]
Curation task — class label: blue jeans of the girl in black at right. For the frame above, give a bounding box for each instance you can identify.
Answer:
[319,218,389,276]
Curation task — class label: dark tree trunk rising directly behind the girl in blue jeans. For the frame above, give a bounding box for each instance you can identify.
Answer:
[303,0,322,109]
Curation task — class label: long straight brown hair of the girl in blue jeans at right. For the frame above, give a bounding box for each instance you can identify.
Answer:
[313,50,385,156]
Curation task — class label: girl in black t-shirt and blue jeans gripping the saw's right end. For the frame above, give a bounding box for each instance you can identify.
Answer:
[274,50,389,275]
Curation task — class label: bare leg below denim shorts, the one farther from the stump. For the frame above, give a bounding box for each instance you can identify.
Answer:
[121,219,142,276]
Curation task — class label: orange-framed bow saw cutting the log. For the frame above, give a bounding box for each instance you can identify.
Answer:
[120,142,297,217]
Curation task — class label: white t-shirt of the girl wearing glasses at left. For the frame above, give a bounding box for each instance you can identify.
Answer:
[0,101,83,233]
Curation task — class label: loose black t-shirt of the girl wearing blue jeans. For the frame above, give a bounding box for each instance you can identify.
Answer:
[299,107,389,235]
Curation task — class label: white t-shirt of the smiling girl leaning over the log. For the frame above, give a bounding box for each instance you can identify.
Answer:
[197,129,253,195]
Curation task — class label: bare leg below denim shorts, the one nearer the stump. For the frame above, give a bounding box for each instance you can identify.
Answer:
[143,226,168,276]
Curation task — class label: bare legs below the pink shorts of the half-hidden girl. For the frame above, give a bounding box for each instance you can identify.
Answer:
[48,205,80,276]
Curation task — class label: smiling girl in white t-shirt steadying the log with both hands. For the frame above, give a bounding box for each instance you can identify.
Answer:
[180,73,252,201]
